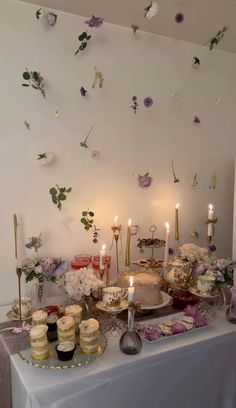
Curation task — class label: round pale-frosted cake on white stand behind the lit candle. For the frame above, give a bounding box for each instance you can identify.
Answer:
[117,271,162,306]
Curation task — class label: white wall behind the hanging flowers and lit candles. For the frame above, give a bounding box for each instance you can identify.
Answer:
[0,0,236,303]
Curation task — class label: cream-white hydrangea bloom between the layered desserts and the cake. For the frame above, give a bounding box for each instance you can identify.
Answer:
[65,268,103,300]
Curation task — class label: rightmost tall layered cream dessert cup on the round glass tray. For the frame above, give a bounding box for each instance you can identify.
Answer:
[79,318,99,354]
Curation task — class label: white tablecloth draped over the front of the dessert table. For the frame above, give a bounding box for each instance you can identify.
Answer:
[11,314,236,408]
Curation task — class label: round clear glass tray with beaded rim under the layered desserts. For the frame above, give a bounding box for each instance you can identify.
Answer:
[18,332,107,370]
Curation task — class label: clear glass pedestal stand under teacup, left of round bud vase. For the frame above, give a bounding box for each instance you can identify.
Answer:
[96,300,128,344]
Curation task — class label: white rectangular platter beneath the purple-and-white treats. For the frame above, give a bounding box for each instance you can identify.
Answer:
[136,312,210,343]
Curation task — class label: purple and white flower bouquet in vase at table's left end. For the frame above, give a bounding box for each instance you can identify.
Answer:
[21,257,68,283]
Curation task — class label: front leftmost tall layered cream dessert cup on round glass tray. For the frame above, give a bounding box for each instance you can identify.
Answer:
[30,324,49,360]
